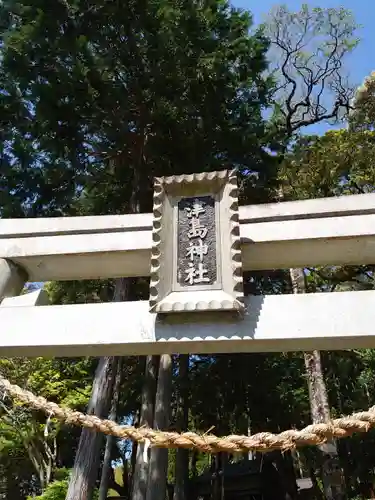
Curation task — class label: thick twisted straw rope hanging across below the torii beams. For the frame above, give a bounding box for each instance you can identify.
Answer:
[0,376,375,453]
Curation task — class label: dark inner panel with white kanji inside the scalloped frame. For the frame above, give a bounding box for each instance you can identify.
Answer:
[177,196,217,288]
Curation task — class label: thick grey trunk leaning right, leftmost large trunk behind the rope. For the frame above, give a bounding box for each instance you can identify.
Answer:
[66,278,130,500]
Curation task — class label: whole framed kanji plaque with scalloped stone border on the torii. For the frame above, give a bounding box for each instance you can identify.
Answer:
[150,170,243,313]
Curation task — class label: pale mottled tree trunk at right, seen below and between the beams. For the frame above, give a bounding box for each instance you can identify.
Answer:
[290,269,346,500]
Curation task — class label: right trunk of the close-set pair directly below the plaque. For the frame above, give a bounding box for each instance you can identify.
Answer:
[146,354,172,500]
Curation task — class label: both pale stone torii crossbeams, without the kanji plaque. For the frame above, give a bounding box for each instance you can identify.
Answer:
[0,170,375,356]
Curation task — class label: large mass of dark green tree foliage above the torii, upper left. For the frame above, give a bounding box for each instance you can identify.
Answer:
[0,0,274,219]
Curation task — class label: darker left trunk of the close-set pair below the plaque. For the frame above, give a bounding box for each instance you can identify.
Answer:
[132,356,160,500]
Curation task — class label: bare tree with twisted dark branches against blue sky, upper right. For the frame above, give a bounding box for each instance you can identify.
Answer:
[264,5,358,138]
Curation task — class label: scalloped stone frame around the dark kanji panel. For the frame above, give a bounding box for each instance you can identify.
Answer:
[150,170,244,313]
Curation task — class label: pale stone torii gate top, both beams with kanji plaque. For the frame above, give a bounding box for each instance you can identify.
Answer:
[0,171,375,356]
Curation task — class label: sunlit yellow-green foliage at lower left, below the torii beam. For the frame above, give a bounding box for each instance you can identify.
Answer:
[0,358,94,492]
